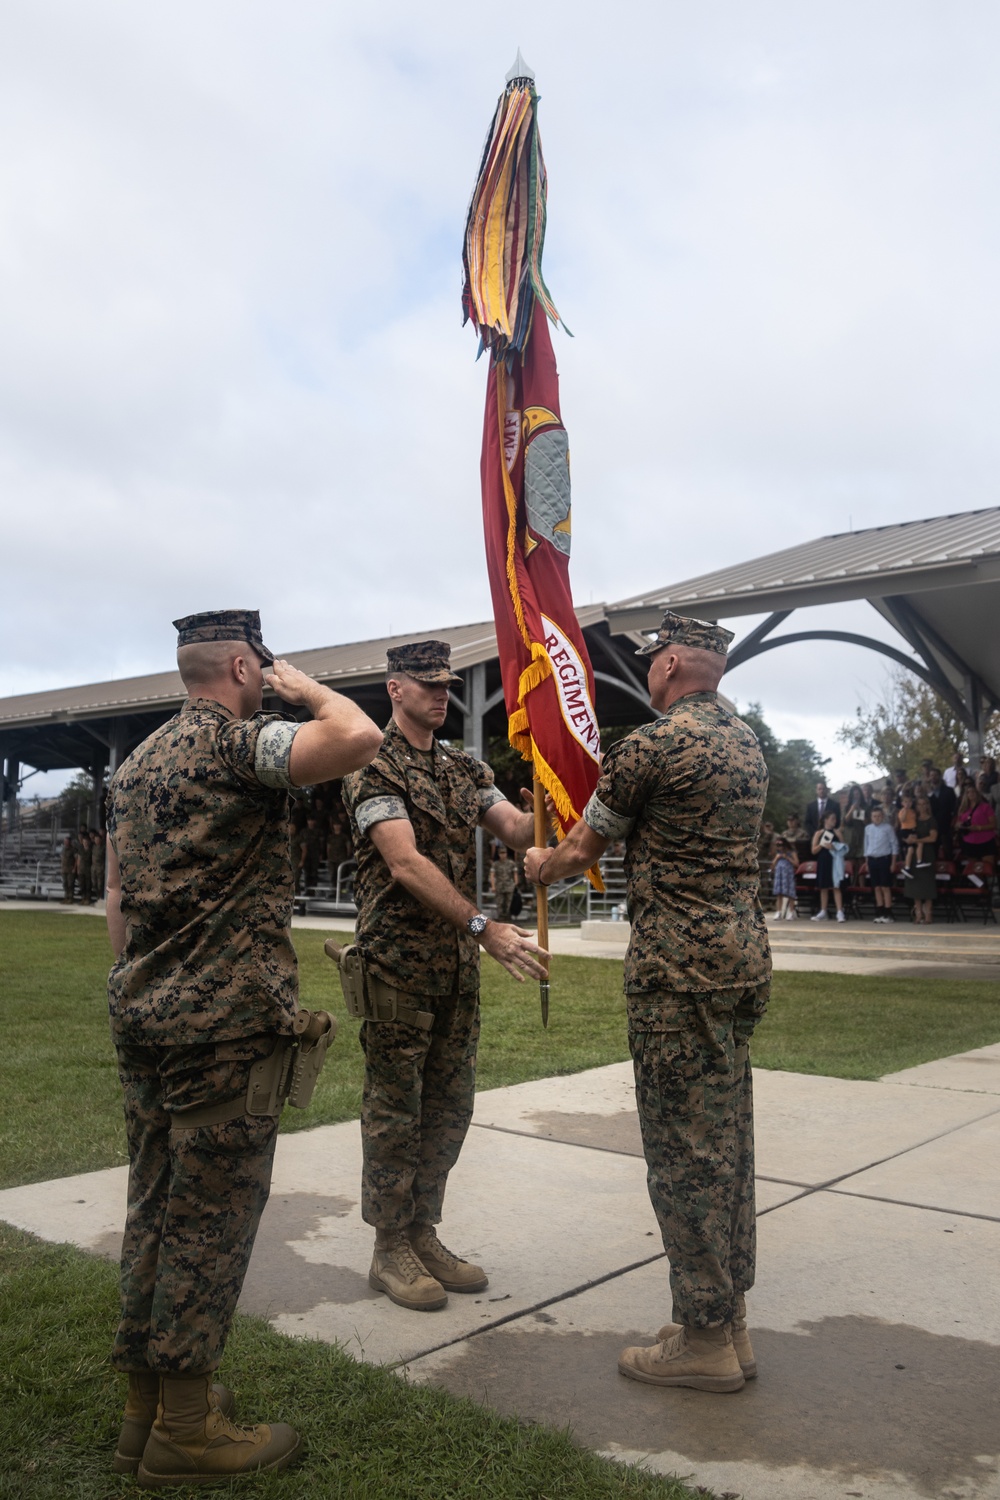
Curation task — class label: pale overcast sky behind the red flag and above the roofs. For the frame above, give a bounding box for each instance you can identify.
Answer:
[0,0,1000,791]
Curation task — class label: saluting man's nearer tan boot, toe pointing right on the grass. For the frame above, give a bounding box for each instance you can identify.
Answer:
[138,1376,301,1490]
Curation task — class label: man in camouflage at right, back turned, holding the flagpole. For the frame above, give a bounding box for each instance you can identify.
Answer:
[525,612,771,1392]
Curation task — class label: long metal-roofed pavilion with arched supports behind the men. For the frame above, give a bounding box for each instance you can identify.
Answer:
[0,507,1000,812]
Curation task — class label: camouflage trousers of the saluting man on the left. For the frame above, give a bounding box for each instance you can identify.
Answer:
[111,1035,277,1374]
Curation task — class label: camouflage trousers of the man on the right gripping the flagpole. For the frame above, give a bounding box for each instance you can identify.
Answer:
[628,986,768,1328]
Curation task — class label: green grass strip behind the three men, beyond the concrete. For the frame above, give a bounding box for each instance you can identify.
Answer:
[0,909,1000,1187]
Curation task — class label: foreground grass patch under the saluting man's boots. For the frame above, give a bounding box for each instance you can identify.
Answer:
[0,1226,694,1500]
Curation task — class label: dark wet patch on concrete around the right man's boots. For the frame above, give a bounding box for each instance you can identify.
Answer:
[419,1308,1000,1500]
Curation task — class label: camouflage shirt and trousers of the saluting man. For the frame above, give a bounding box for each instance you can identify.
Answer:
[108,699,297,1374]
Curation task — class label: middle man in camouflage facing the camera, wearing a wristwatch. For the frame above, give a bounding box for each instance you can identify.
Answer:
[343,641,547,1311]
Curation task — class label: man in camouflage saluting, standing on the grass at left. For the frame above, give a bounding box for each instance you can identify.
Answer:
[108,609,382,1488]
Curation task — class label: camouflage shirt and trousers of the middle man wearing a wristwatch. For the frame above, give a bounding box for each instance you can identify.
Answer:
[343,722,504,1230]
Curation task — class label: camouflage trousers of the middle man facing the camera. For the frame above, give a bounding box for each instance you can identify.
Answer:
[360,993,480,1230]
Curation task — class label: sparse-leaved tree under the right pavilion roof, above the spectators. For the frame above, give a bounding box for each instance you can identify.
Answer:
[837,668,1000,776]
